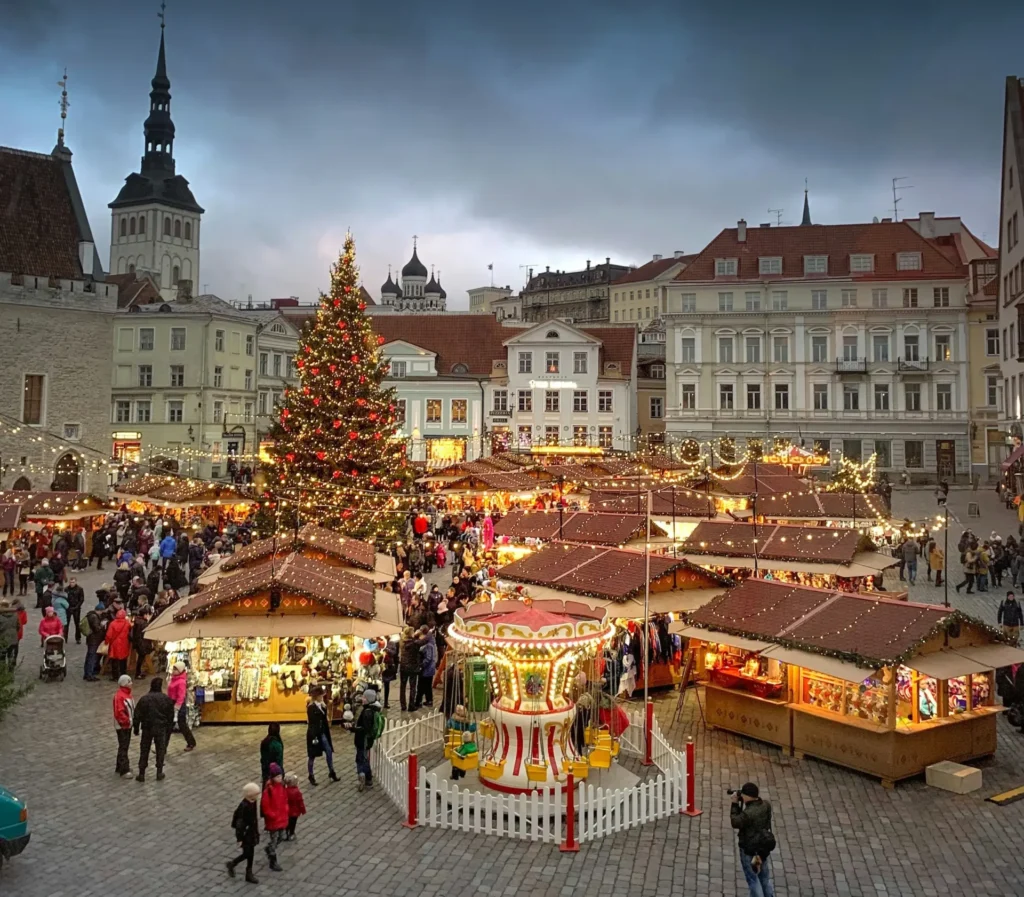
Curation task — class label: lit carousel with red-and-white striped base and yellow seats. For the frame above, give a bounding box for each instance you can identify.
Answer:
[445,597,635,794]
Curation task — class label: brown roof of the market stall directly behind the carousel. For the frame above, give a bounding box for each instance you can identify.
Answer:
[498,542,731,600]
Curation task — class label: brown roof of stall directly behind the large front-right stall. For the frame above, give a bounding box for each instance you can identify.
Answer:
[681,522,861,564]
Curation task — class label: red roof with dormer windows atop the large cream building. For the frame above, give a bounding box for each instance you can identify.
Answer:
[676,221,965,284]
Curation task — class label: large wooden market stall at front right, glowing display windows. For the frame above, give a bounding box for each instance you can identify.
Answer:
[675,580,1024,785]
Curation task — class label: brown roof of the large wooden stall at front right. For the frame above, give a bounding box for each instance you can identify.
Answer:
[689,580,954,666]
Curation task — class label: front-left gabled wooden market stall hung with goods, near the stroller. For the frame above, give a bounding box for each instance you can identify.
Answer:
[145,552,402,723]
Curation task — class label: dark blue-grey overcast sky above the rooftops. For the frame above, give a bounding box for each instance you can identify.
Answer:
[0,0,1024,307]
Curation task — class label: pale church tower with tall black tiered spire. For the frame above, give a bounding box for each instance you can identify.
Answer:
[110,12,204,301]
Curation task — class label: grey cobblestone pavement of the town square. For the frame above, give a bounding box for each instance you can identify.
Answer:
[0,492,1024,897]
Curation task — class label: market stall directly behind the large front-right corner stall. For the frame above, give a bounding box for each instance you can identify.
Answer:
[679,522,898,592]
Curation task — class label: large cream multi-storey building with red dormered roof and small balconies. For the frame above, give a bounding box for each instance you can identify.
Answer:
[666,221,970,478]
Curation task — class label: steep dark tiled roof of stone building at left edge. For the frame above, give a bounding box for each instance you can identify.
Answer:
[0,146,83,280]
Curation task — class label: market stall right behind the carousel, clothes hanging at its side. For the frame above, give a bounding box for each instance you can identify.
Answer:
[498,542,732,689]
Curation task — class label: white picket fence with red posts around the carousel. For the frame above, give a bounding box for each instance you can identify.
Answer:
[373,710,689,843]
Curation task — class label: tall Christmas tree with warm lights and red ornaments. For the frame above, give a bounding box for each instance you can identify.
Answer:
[269,234,411,539]
